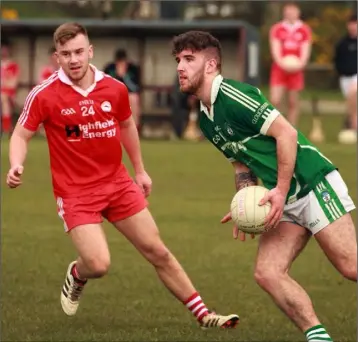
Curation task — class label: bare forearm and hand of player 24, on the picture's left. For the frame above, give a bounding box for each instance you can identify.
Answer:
[6,124,35,188]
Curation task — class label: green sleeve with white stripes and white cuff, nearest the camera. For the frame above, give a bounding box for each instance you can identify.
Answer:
[230,87,280,135]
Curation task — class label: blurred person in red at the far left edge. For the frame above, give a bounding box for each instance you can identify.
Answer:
[1,39,20,133]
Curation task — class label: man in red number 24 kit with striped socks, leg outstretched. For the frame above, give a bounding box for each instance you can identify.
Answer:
[7,23,239,328]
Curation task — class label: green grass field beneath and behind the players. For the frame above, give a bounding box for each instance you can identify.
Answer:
[1,116,357,342]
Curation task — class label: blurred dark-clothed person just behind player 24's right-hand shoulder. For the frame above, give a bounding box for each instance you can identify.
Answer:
[104,49,141,131]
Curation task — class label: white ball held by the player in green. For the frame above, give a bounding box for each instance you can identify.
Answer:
[230,185,271,234]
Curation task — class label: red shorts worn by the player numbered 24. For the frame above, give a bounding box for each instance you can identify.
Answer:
[57,177,148,232]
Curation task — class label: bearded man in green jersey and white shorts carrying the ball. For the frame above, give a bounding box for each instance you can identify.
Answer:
[172,31,357,341]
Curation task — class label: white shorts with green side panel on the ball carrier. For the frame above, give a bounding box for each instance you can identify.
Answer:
[281,170,355,235]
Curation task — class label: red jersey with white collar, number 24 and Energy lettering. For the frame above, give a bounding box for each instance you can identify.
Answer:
[19,66,131,197]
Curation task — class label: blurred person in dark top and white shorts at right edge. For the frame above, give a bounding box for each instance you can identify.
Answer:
[334,15,357,131]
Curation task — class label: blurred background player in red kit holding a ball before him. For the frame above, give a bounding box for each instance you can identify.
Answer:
[269,3,312,125]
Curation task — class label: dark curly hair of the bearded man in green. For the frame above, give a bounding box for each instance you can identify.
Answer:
[172,31,221,70]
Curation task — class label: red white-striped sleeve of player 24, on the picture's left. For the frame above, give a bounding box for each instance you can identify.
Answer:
[18,88,44,132]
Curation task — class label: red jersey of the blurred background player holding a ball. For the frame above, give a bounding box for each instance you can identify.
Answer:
[270,20,312,57]
